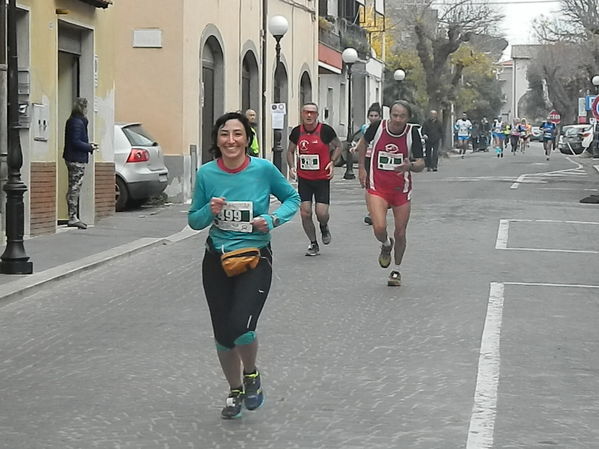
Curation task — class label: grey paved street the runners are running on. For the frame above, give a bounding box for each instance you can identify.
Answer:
[0,143,599,449]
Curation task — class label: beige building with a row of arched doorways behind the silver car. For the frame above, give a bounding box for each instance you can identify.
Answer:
[114,0,318,201]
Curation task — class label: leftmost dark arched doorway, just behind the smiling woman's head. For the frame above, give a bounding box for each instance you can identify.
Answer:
[200,37,224,164]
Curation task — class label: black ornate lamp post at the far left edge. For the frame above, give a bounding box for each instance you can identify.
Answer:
[0,0,33,274]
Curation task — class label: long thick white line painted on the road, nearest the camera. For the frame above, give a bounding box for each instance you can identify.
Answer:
[466,282,504,449]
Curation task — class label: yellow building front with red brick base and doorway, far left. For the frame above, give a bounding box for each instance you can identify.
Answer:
[0,0,114,242]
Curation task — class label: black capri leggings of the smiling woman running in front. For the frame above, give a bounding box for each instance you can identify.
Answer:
[202,245,272,349]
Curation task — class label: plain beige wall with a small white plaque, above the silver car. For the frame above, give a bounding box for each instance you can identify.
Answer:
[114,0,184,155]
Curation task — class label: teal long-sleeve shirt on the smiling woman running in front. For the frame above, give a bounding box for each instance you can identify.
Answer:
[187,158,300,252]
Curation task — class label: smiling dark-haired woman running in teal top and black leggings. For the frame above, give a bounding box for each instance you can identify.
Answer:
[188,112,300,419]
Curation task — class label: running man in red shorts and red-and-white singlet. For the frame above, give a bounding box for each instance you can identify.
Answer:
[357,100,425,286]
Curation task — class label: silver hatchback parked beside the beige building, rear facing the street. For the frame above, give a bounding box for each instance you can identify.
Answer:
[114,123,168,211]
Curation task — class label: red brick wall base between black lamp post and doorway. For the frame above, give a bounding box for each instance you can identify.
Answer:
[29,162,56,235]
